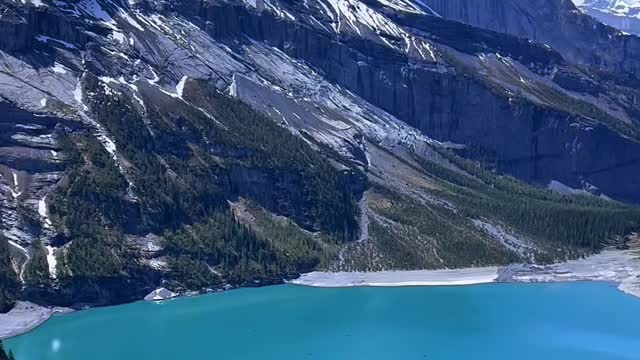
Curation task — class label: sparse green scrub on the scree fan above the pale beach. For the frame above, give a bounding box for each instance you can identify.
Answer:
[369,186,520,269]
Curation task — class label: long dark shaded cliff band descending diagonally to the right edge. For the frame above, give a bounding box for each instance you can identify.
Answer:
[198,1,640,202]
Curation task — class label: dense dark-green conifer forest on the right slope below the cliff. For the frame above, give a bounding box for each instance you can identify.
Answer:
[418,146,640,251]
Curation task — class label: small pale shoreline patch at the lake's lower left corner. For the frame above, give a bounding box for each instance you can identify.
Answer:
[0,302,72,339]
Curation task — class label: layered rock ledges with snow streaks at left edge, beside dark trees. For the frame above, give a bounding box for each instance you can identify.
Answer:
[0,103,73,246]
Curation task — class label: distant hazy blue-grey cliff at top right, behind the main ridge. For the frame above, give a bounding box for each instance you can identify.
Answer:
[425,0,640,77]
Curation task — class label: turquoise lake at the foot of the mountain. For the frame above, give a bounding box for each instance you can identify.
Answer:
[7,283,640,360]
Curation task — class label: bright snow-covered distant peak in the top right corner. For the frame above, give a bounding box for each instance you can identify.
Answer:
[574,0,640,35]
